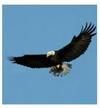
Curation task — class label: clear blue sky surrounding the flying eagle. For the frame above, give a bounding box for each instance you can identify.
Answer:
[3,5,97,104]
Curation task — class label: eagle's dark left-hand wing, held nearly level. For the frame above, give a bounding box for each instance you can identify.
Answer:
[9,54,55,68]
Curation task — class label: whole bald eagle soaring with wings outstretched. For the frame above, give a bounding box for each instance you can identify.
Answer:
[9,23,96,76]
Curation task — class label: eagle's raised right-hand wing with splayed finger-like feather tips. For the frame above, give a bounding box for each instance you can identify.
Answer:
[57,23,96,62]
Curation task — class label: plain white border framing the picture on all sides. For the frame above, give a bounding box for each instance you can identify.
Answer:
[0,0,100,108]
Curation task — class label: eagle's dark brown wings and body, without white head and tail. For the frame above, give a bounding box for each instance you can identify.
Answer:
[10,23,96,68]
